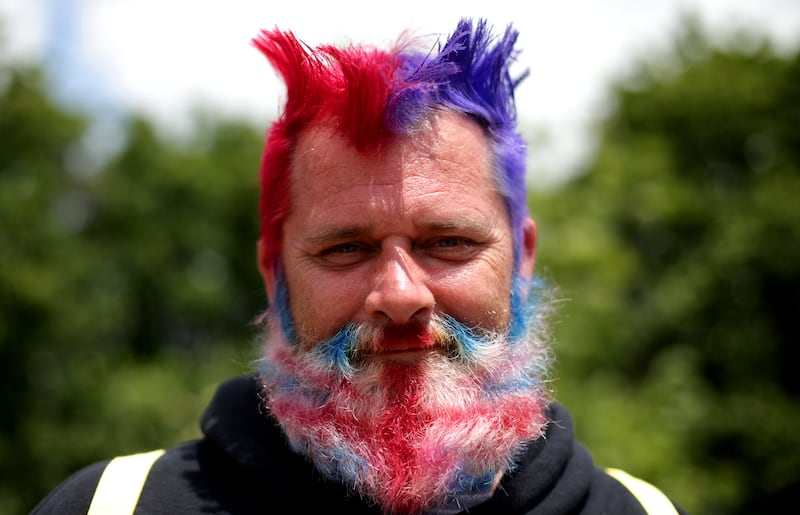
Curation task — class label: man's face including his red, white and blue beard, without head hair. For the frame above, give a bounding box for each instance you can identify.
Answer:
[259,114,548,513]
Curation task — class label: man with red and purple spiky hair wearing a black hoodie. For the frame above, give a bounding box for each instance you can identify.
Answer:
[34,20,682,514]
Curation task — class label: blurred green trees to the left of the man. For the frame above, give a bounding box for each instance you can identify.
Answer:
[0,59,265,514]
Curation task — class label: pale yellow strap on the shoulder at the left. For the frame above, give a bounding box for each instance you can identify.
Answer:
[86,449,164,515]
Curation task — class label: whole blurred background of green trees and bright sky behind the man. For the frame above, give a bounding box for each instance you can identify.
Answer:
[0,0,800,515]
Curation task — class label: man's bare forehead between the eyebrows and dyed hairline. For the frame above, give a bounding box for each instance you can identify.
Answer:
[290,113,497,204]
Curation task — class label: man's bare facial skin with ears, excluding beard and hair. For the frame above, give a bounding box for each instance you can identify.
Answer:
[262,114,535,352]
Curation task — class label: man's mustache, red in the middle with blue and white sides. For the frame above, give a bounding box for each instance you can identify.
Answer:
[310,314,505,376]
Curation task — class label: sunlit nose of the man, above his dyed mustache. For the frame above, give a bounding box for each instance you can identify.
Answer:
[366,247,435,324]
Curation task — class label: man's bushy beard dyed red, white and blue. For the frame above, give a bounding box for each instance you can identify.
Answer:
[261,280,549,513]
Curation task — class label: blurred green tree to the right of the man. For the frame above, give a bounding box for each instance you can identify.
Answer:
[532,16,800,514]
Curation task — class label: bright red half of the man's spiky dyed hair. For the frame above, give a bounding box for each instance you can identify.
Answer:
[253,30,402,267]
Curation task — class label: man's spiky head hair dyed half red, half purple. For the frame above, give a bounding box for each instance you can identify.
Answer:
[253,19,528,267]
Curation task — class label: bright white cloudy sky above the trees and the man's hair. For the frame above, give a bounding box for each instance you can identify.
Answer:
[0,0,800,185]
